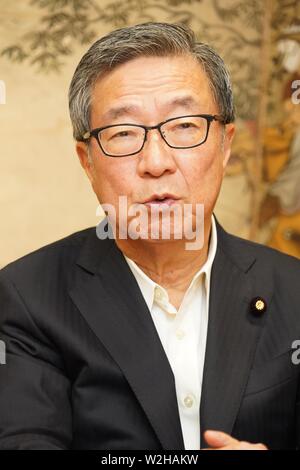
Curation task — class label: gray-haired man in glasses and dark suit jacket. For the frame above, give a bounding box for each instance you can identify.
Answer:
[0,23,300,450]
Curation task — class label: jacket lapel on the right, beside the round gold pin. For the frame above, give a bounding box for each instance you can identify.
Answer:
[200,225,272,447]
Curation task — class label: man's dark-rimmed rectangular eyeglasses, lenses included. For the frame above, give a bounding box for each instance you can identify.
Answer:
[82,114,225,157]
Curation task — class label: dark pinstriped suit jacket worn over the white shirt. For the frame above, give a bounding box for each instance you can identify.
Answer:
[0,218,300,450]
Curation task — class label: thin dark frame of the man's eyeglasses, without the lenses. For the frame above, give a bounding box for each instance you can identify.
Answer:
[82,114,226,158]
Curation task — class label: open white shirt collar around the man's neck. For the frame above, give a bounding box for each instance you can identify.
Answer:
[124,215,217,311]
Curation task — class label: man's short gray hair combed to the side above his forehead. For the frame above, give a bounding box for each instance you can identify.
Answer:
[69,22,234,141]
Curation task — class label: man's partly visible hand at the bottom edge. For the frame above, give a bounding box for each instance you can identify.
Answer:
[202,431,268,450]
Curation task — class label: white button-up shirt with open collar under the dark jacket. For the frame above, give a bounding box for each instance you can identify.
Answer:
[124,217,217,450]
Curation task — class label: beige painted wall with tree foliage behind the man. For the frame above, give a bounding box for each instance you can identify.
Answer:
[0,0,300,266]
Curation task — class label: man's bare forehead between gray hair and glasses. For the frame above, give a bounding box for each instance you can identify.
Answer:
[91,56,215,121]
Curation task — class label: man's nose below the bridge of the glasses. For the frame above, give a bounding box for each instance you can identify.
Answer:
[137,129,177,177]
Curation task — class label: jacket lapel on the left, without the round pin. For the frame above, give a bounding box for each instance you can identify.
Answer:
[70,222,184,449]
